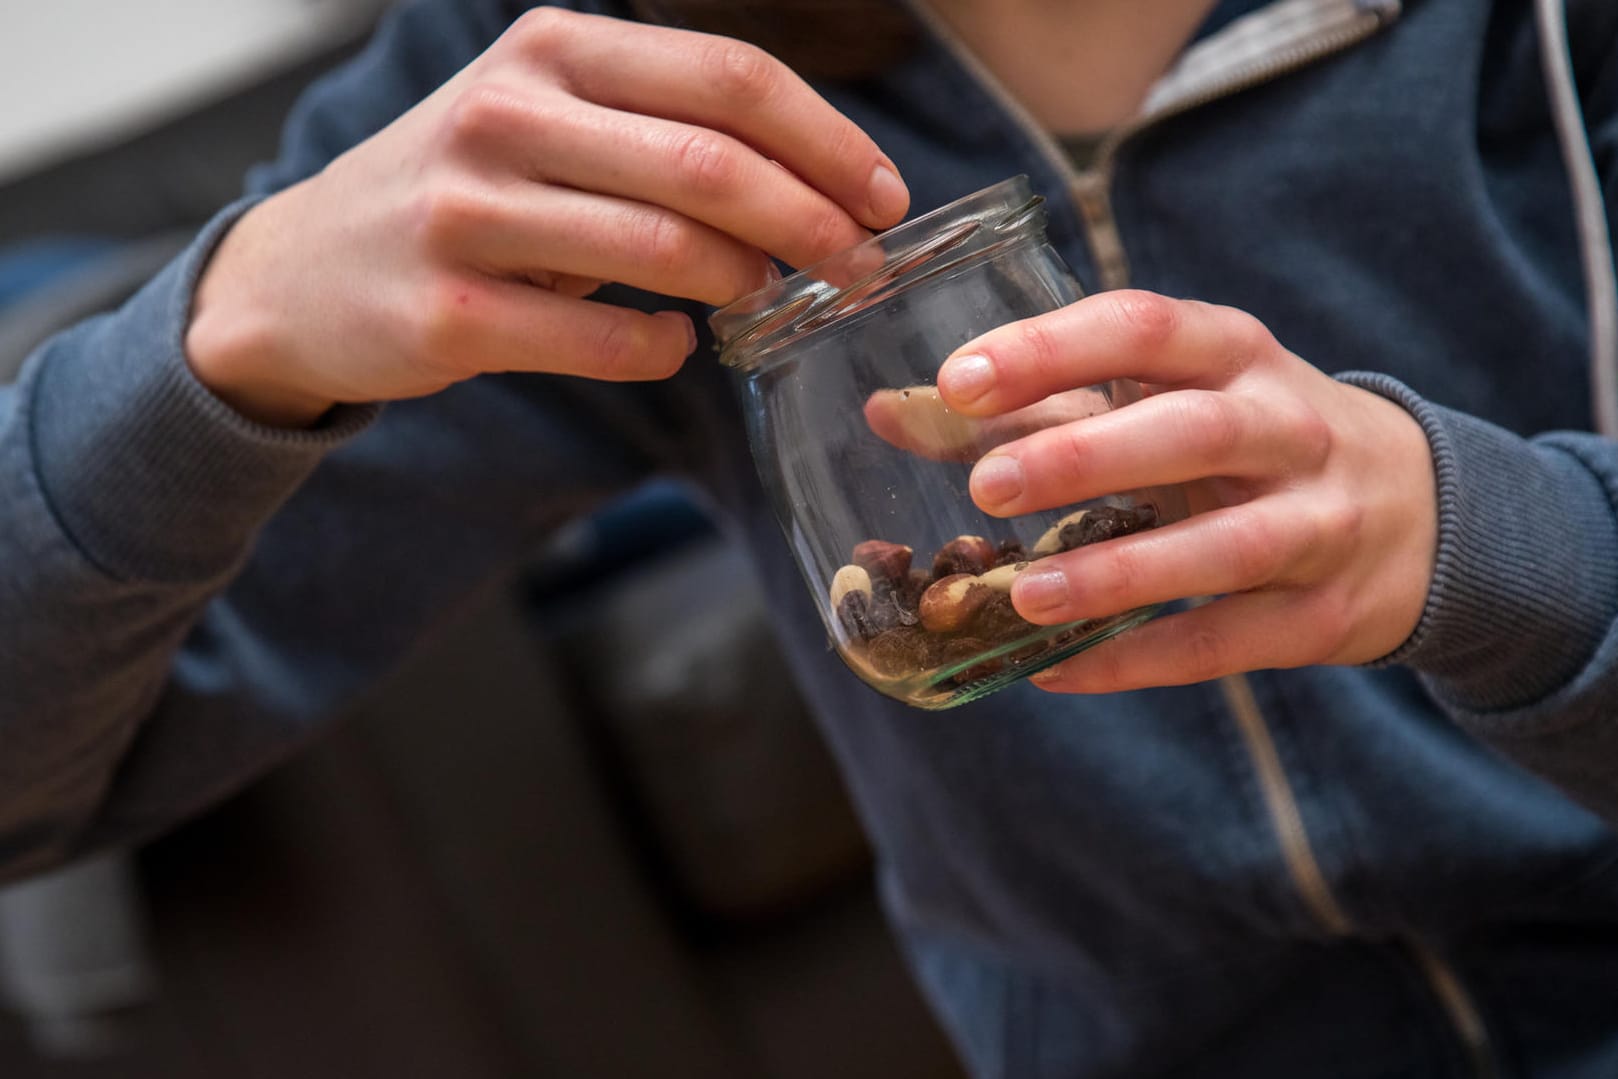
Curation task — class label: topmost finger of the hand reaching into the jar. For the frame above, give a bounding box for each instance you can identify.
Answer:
[533,16,909,232]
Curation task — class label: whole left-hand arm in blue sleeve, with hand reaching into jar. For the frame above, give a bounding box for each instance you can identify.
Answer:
[0,0,906,872]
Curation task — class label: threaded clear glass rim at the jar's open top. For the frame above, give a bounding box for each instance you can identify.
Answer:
[707,176,1045,370]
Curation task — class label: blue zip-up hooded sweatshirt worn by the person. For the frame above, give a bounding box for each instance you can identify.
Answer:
[0,0,1618,1079]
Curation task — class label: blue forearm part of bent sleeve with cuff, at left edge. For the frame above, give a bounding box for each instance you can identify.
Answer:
[0,214,369,874]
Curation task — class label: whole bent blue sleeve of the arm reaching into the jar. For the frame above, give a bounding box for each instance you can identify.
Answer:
[0,0,695,878]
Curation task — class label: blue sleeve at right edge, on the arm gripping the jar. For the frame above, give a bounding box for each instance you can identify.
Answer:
[1345,23,1618,827]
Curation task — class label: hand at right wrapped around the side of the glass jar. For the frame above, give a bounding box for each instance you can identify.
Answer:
[938,291,1438,692]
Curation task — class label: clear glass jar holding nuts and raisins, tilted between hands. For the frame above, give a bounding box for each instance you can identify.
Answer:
[709,176,1186,709]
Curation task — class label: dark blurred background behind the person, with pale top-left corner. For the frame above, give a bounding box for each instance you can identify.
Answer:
[0,0,959,1079]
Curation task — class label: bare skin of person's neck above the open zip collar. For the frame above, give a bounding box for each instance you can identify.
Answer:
[925,0,1215,136]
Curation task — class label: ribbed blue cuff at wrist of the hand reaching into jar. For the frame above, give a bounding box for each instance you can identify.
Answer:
[19,199,377,581]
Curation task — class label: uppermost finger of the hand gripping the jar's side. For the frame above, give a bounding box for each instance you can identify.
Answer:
[938,290,1278,416]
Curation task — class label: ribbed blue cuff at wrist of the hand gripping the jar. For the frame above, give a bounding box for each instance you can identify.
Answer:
[1338,372,1618,713]
